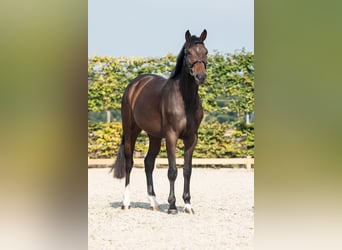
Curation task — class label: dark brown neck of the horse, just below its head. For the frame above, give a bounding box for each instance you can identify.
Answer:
[179,70,200,110]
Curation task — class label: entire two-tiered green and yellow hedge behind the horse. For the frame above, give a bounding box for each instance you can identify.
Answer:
[88,50,254,158]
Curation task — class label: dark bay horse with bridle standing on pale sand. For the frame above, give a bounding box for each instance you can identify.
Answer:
[112,30,208,214]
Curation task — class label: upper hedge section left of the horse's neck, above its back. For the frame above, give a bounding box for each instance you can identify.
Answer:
[88,54,176,112]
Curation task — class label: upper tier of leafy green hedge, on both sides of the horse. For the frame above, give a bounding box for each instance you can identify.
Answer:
[88,50,254,119]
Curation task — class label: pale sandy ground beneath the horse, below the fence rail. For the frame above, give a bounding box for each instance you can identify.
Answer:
[88,168,254,250]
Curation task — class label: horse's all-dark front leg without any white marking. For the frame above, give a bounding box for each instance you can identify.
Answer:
[166,134,178,214]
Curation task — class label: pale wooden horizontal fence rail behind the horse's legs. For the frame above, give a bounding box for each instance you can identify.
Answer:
[88,156,254,169]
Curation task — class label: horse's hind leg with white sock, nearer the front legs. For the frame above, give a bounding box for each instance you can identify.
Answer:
[144,136,161,210]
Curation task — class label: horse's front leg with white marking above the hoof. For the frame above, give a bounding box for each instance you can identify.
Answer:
[183,134,197,214]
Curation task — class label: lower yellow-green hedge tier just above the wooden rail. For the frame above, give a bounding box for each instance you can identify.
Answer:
[88,122,254,158]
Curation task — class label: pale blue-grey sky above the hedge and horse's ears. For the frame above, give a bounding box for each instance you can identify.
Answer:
[88,0,254,57]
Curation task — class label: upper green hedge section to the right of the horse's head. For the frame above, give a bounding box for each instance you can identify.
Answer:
[200,51,254,120]
